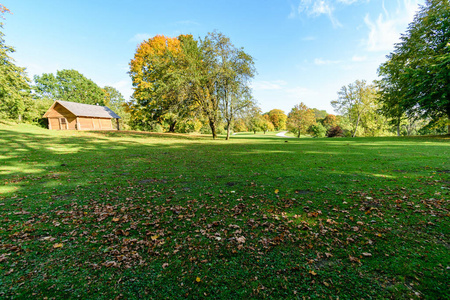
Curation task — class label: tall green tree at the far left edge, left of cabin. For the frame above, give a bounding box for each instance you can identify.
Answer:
[0,4,32,121]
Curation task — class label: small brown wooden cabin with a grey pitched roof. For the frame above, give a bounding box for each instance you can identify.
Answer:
[43,100,120,130]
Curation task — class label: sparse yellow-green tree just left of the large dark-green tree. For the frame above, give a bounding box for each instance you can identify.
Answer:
[331,80,376,137]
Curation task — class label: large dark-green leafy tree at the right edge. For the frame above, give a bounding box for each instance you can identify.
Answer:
[378,0,450,134]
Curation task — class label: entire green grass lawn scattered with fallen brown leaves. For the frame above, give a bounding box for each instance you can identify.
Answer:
[0,124,450,299]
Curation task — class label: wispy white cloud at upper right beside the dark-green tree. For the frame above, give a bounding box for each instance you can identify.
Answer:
[364,0,422,51]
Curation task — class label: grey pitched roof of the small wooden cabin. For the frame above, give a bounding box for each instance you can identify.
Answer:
[44,100,120,119]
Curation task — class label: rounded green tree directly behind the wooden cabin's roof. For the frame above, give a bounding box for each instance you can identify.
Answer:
[34,70,105,105]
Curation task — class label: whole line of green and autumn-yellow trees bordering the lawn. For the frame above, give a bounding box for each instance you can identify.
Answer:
[0,0,450,139]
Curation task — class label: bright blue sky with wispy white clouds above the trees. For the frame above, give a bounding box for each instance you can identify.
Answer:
[0,0,424,114]
